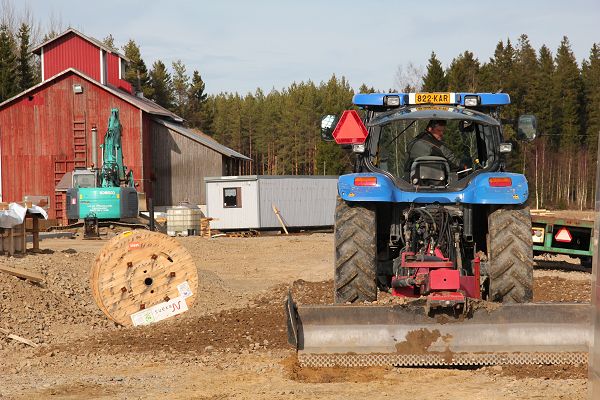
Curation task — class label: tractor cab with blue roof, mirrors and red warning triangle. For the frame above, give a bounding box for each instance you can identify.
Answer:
[322,93,535,191]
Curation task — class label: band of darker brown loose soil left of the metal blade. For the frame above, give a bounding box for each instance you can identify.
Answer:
[46,280,332,355]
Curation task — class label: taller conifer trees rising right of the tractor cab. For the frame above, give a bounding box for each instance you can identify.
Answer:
[412,35,600,209]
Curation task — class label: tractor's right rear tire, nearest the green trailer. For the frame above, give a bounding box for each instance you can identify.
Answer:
[487,206,533,303]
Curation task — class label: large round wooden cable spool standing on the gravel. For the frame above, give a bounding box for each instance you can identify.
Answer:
[90,230,198,326]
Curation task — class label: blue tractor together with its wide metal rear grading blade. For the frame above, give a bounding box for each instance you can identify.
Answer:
[285,93,591,367]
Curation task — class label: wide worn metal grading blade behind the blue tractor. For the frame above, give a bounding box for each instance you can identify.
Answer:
[285,295,591,367]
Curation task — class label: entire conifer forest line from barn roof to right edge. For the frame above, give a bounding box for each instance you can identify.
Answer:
[126,35,600,209]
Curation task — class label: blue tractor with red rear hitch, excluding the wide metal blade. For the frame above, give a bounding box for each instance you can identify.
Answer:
[321,93,536,311]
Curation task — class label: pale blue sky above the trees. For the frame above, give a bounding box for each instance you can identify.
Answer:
[13,0,600,94]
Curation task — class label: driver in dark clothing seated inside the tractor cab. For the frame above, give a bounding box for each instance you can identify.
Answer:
[405,120,460,172]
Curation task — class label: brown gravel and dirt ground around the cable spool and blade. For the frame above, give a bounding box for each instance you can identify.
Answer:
[0,234,591,399]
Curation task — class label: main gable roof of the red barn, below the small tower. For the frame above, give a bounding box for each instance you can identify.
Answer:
[0,68,183,122]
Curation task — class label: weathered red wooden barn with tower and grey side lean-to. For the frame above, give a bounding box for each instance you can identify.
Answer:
[0,29,250,219]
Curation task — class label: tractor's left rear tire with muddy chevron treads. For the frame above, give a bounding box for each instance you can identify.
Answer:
[334,197,377,303]
